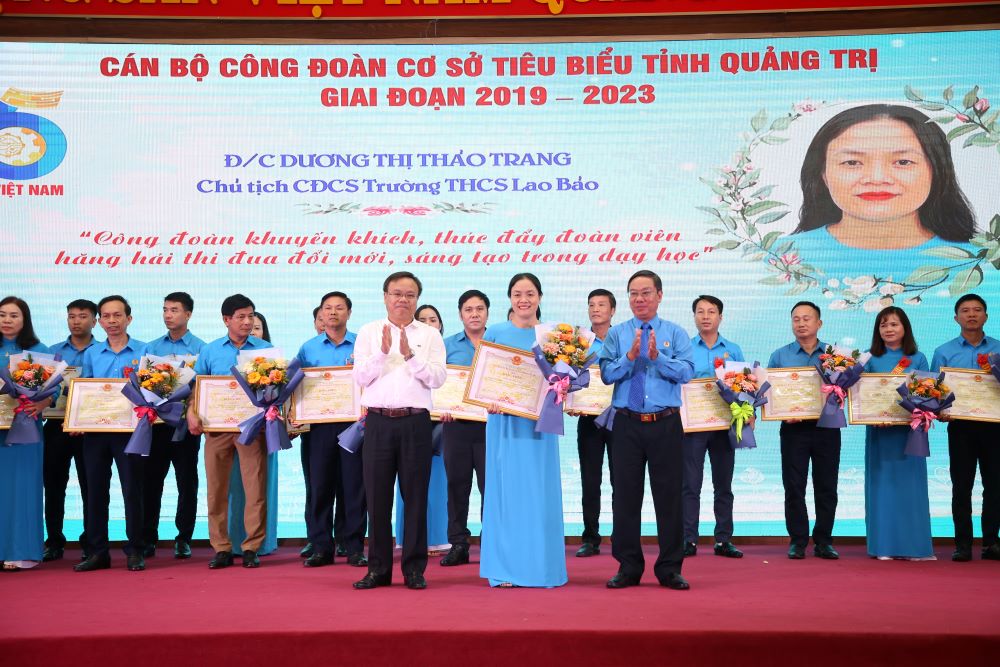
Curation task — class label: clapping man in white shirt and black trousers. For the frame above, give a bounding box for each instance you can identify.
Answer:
[354,271,446,590]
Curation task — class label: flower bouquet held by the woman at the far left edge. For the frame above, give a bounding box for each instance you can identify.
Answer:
[0,352,66,445]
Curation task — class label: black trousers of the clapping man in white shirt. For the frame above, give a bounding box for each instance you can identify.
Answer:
[363,412,433,576]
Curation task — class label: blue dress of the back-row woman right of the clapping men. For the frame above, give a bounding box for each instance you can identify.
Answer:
[865,350,934,558]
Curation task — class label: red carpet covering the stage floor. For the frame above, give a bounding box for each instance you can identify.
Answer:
[0,545,1000,667]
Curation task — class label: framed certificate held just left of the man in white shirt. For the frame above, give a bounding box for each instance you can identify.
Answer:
[288,366,361,424]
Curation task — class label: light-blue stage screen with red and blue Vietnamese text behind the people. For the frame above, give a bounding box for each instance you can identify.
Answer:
[0,31,1000,537]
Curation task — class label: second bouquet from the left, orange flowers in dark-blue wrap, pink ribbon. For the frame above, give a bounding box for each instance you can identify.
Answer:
[122,354,194,456]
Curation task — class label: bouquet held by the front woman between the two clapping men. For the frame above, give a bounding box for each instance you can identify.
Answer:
[531,324,594,435]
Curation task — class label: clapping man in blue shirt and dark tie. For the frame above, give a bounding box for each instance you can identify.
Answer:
[600,270,694,590]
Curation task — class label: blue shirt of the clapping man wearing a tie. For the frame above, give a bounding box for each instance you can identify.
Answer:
[599,316,694,412]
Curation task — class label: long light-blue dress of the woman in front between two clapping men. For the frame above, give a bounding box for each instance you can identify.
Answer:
[479,322,567,588]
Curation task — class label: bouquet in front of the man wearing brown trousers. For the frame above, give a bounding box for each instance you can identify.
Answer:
[230,348,305,454]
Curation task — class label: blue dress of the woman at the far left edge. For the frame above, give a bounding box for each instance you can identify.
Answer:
[0,338,49,561]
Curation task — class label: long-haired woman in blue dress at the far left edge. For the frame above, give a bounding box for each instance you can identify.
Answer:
[0,296,51,572]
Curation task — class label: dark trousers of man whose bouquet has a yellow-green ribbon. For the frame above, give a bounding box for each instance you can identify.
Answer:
[684,431,736,542]
